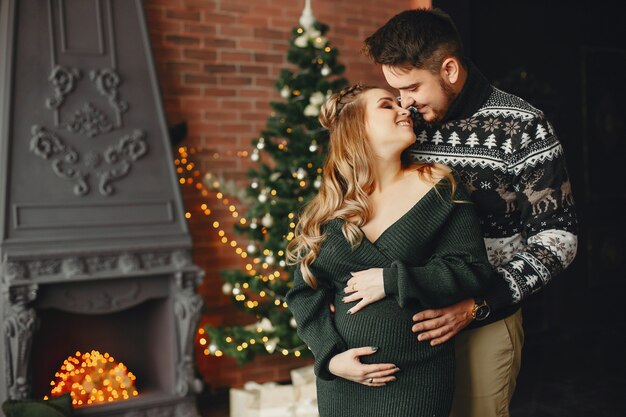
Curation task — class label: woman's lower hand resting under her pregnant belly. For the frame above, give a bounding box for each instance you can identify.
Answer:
[328,347,400,387]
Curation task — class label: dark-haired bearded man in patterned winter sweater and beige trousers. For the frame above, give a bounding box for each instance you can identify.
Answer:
[356,9,577,417]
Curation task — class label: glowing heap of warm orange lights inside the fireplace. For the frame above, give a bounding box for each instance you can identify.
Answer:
[44,350,139,407]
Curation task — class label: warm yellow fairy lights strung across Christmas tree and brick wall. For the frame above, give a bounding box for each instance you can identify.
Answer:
[174,146,310,357]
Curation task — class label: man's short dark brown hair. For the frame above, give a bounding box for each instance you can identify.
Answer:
[363,8,463,73]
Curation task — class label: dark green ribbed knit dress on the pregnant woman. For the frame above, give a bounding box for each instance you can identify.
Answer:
[287,180,494,417]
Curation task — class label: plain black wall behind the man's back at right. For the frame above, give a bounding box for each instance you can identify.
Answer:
[433,0,626,415]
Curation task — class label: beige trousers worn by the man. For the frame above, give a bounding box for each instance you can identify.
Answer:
[450,310,524,417]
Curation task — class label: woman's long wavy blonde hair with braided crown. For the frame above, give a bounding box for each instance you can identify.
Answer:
[286,84,455,288]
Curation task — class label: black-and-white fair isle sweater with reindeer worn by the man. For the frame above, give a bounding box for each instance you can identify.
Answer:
[411,62,577,326]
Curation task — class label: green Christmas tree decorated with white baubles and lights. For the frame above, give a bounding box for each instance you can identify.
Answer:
[205,2,348,363]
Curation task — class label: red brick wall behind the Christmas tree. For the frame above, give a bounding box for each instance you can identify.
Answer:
[144,0,430,387]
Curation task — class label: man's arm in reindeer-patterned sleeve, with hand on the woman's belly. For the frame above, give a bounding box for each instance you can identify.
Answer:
[413,116,578,345]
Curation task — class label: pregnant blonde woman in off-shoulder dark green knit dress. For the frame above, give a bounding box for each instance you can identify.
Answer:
[287,85,492,417]
